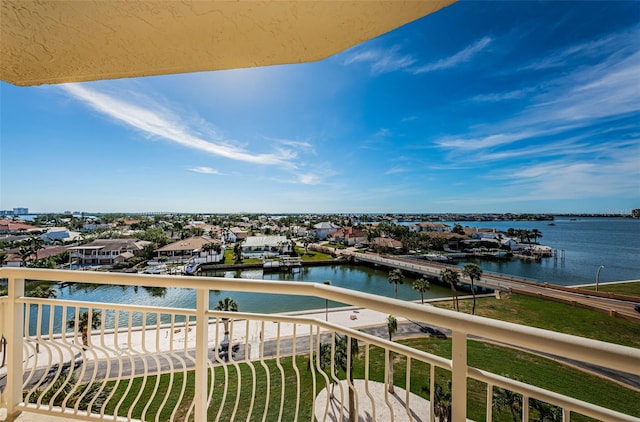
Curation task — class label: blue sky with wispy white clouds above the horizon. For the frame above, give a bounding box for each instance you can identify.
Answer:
[0,1,640,213]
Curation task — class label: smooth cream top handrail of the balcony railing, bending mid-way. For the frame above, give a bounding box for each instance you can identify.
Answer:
[0,268,640,373]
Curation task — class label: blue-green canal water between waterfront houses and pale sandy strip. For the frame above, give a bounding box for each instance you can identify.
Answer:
[29,265,450,334]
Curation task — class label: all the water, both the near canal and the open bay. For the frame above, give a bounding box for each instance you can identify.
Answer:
[22,217,640,327]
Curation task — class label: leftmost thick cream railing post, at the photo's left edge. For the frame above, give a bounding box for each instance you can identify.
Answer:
[5,277,24,420]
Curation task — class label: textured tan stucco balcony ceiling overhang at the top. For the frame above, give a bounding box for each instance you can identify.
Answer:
[0,0,455,86]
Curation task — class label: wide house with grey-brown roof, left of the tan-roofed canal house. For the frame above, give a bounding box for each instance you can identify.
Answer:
[68,239,151,265]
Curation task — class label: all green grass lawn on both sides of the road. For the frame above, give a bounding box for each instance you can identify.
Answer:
[41,295,640,421]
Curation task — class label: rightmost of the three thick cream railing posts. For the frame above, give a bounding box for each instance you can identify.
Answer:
[451,330,467,422]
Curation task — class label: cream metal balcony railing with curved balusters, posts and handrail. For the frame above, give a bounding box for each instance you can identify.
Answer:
[0,268,640,421]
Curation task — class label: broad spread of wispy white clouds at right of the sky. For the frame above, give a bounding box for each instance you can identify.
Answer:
[435,26,640,203]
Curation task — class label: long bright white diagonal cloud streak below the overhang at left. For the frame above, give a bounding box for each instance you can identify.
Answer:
[61,84,296,169]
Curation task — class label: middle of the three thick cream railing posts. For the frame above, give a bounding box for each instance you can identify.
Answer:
[194,289,209,422]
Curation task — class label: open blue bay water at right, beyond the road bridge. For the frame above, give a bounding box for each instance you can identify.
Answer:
[449,217,640,286]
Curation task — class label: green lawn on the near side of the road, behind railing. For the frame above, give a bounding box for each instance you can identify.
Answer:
[91,332,640,421]
